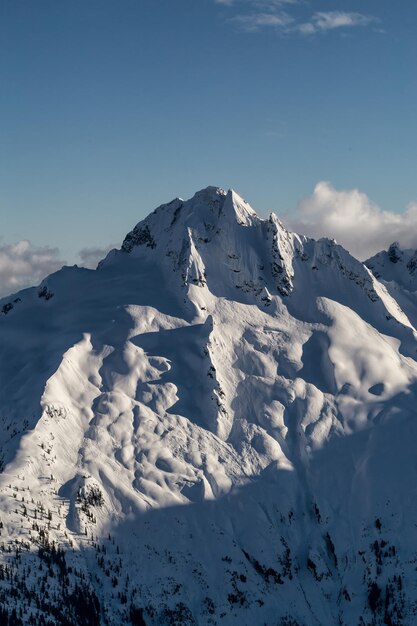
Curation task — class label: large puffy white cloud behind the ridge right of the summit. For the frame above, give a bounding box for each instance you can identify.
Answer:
[285,181,417,260]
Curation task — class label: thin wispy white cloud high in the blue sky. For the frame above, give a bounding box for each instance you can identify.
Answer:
[215,0,377,36]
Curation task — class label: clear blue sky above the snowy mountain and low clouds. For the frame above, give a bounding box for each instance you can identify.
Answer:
[0,0,417,289]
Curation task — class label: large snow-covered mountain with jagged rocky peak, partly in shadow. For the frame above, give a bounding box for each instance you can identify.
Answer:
[0,187,417,626]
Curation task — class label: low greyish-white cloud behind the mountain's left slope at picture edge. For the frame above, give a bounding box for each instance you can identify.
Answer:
[0,240,63,297]
